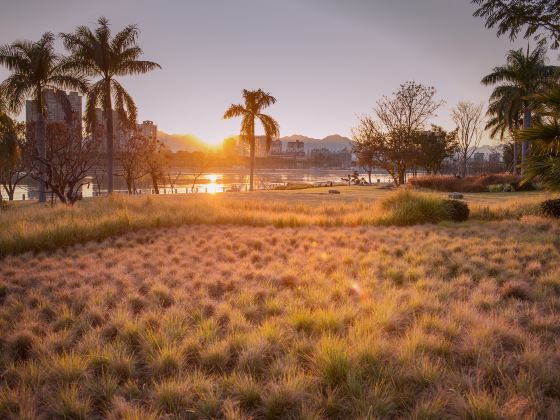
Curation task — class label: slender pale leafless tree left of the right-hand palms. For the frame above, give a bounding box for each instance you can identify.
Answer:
[451,101,484,176]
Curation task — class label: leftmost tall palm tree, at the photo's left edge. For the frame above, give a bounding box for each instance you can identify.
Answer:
[0,32,87,202]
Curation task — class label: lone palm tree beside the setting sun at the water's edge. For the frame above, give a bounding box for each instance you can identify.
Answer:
[224,89,280,191]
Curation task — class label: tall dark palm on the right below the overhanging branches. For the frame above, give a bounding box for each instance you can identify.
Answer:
[482,45,559,172]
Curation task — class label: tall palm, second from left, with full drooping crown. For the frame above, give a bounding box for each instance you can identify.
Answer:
[60,17,161,192]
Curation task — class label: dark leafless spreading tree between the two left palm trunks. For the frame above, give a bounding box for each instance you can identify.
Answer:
[27,123,100,205]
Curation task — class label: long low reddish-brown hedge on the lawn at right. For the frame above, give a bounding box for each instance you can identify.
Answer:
[408,174,534,192]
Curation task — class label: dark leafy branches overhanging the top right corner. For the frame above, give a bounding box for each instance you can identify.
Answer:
[472,0,560,48]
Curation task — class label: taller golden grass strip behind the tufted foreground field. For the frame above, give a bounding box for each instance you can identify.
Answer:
[0,187,545,259]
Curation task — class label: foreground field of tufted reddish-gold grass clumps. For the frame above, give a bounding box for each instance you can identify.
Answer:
[0,218,560,419]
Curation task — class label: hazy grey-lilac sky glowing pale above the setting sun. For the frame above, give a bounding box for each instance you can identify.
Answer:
[0,0,558,143]
